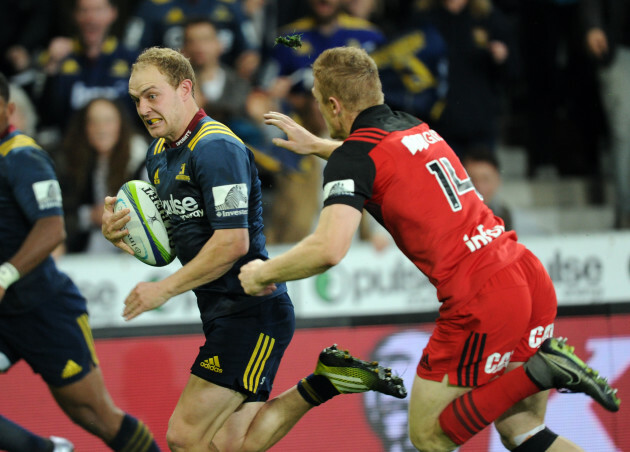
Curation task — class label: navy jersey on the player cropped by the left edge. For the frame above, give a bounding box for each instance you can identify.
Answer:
[0,130,78,315]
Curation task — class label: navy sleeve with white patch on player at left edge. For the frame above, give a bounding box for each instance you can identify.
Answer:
[6,148,63,223]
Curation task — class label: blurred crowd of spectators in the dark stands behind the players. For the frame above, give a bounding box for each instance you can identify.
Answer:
[0,0,630,252]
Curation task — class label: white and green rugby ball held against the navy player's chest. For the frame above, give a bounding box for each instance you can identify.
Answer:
[114,180,175,267]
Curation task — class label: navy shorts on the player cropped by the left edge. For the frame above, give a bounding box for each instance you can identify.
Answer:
[0,287,98,387]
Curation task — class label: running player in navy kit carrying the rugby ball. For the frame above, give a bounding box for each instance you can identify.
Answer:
[103,47,406,451]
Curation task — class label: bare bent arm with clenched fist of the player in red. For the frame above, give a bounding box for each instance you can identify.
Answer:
[239,204,361,295]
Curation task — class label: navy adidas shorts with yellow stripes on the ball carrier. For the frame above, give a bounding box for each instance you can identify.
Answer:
[190,292,295,402]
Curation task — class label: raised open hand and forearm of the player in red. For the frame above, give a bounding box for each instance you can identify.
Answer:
[264,111,342,160]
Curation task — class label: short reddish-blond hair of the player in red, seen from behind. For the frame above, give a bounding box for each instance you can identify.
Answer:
[313,47,385,111]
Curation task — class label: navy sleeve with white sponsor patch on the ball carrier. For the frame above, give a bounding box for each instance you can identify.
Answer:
[193,138,252,230]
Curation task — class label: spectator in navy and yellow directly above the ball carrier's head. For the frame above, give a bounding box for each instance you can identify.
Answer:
[125,0,260,78]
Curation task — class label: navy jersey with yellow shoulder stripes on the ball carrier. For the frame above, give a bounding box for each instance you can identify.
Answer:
[146,110,286,321]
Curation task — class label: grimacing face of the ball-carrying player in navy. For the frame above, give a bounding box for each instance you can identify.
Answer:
[129,66,188,141]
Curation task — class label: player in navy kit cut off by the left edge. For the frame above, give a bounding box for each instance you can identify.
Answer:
[0,74,159,452]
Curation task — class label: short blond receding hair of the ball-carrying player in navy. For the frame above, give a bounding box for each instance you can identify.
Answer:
[131,47,197,97]
